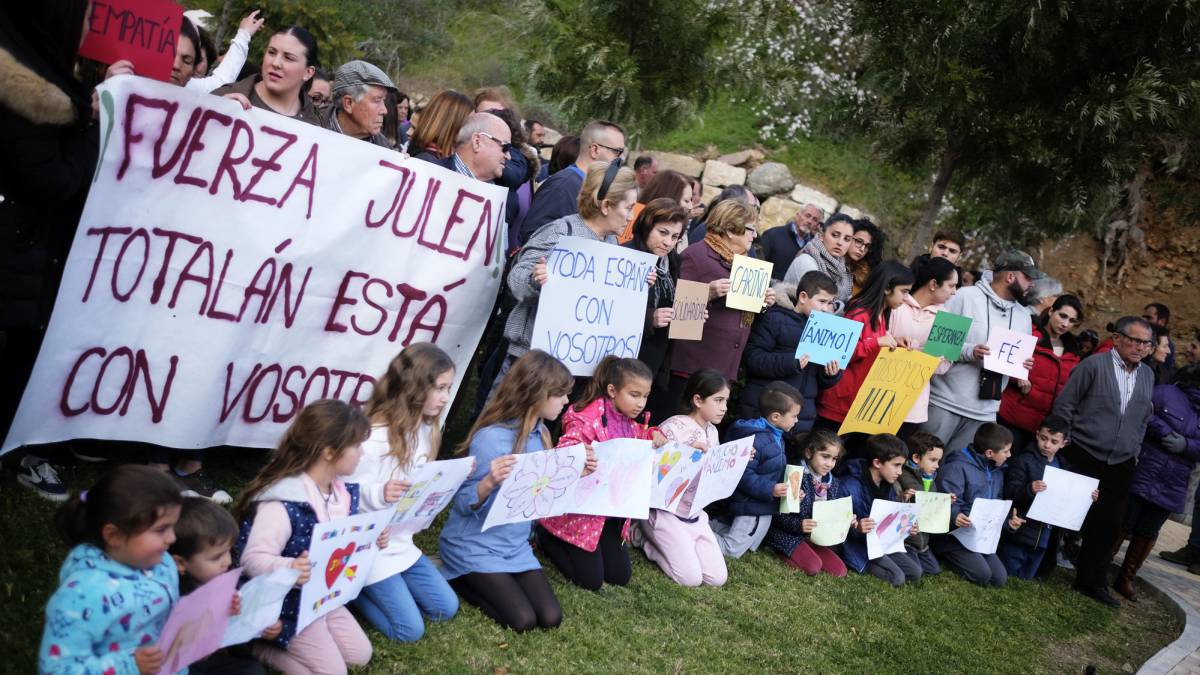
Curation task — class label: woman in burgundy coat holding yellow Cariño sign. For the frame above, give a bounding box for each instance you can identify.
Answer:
[671,199,775,401]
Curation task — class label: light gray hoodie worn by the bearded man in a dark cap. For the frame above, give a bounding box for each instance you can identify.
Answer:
[929,275,1033,422]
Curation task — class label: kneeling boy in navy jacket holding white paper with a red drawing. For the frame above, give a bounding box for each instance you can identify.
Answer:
[841,434,922,587]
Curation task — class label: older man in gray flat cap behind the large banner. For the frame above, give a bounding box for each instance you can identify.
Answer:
[325,61,396,150]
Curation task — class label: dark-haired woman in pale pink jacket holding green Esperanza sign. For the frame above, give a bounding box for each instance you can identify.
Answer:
[888,258,959,438]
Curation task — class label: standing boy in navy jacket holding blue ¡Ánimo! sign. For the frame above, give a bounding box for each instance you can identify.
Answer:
[737,271,841,441]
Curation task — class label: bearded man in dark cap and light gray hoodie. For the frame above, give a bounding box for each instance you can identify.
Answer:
[922,251,1045,454]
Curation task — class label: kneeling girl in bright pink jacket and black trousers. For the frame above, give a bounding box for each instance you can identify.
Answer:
[536,356,667,591]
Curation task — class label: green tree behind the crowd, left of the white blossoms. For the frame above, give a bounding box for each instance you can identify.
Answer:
[522,0,727,137]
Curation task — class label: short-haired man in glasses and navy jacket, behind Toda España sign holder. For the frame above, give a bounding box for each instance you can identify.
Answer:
[518,120,625,246]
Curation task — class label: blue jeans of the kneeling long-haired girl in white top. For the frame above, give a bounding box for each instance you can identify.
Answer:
[350,555,458,643]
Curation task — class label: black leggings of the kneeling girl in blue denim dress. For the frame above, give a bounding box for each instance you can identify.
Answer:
[450,569,563,633]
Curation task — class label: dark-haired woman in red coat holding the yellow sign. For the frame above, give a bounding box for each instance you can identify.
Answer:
[815,261,913,459]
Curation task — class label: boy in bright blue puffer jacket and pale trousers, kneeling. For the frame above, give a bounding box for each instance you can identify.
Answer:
[709,382,804,557]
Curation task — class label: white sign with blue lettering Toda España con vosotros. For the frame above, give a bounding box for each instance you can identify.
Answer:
[529,237,658,377]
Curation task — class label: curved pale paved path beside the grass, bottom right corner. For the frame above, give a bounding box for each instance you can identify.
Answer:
[1132,520,1200,675]
